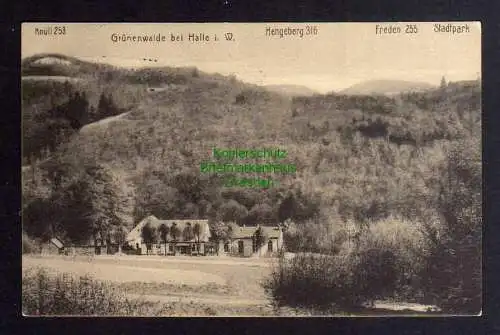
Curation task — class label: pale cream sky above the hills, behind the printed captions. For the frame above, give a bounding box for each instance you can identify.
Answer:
[21,23,481,92]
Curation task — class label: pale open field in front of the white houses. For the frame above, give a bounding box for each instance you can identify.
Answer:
[22,255,442,316]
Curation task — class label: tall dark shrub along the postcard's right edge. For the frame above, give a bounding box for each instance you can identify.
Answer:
[420,137,482,314]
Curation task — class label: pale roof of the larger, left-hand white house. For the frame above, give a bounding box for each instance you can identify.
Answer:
[127,215,210,242]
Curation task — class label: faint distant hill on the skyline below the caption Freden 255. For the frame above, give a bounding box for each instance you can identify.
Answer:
[340,80,435,95]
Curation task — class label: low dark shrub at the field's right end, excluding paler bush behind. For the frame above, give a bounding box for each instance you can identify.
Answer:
[264,249,395,311]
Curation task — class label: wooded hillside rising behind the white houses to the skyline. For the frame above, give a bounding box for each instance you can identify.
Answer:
[23,55,481,252]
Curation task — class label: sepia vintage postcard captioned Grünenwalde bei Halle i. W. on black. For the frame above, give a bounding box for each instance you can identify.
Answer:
[21,22,482,317]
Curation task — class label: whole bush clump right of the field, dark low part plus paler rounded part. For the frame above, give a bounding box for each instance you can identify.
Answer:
[264,217,425,311]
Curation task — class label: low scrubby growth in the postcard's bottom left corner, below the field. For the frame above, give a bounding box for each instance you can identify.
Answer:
[22,268,155,316]
